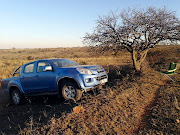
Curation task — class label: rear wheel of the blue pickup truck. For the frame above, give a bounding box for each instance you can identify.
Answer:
[10,89,22,105]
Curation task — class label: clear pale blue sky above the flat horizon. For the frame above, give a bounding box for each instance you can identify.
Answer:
[0,0,180,49]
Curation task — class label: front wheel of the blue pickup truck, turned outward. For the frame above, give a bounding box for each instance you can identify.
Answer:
[62,82,82,101]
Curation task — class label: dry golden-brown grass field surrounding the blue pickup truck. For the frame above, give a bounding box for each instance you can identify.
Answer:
[0,46,180,135]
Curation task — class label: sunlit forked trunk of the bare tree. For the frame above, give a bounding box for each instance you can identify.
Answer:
[131,49,148,72]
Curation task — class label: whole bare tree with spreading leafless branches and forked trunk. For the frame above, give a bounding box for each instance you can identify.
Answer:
[84,7,180,71]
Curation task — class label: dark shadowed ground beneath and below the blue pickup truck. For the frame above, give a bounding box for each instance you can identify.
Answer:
[0,90,75,135]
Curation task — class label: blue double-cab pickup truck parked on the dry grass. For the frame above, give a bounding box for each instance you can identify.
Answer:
[1,59,108,105]
